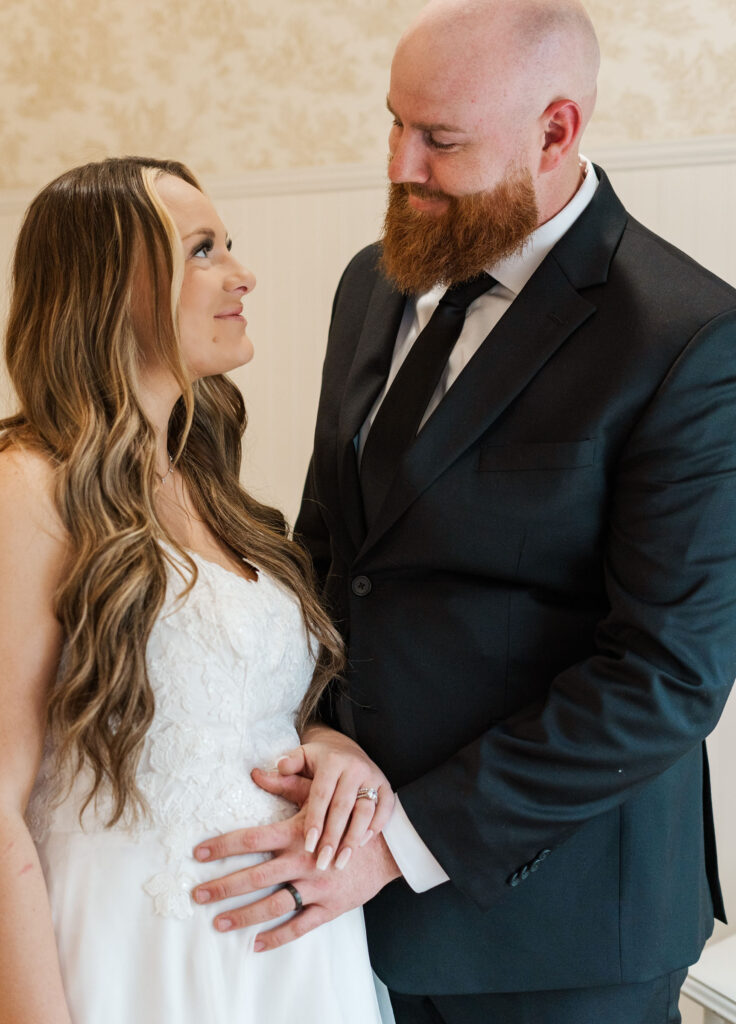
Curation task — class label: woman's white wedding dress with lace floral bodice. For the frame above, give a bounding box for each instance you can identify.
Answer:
[28,556,381,1024]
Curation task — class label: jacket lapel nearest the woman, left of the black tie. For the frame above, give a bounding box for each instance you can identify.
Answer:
[337,274,405,551]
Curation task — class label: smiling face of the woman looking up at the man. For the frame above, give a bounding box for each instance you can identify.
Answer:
[156,174,256,380]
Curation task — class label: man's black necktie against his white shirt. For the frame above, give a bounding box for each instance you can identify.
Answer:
[360,273,495,525]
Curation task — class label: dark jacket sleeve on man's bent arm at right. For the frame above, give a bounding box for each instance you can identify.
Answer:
[399,312,736,907]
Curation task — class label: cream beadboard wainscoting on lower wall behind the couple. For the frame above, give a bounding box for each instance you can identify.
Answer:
[0,135,736,1024]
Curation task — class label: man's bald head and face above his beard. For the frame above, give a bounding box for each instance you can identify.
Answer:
[388,0,600,221]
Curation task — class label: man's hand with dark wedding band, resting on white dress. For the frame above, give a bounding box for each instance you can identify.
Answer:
[192,772,400,952]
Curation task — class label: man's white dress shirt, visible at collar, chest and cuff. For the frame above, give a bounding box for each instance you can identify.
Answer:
[370,157,598,892]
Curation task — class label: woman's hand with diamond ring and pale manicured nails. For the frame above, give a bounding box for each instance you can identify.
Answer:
[254,725,394,870]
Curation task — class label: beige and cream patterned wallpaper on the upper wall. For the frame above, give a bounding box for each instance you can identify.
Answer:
[0,0,736,188]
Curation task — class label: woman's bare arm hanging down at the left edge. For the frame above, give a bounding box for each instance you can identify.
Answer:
[0,450,71,1024]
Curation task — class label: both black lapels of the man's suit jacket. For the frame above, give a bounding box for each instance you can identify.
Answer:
[327,167,627,556]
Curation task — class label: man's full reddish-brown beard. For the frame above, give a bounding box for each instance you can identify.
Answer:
[382,170,538,295]
